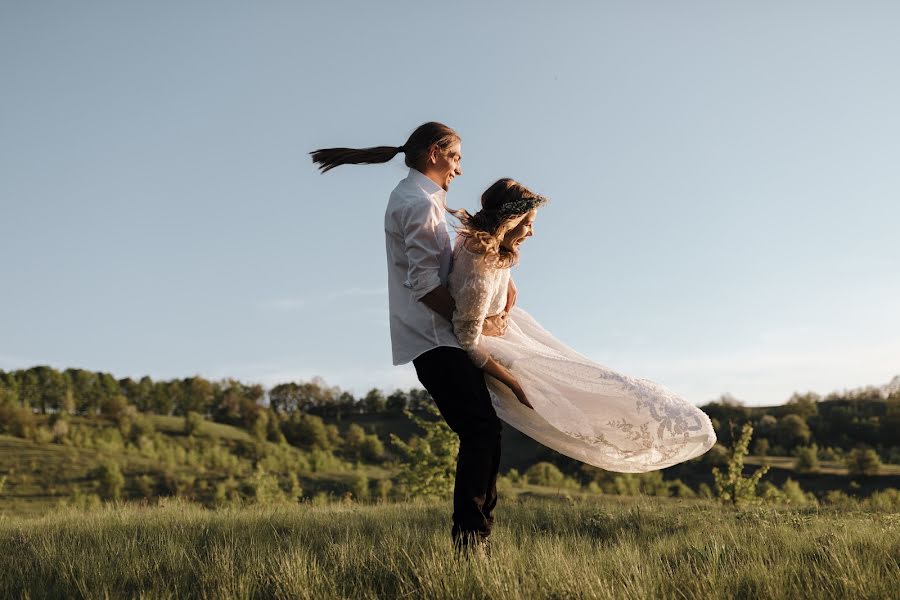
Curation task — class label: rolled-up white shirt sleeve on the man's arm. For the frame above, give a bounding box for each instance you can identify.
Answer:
[400,201,444,300]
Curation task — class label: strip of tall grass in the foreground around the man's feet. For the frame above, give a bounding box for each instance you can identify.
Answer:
[0,498,900,599]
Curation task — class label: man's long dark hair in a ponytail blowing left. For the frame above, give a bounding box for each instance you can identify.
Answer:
[310,121,460,173]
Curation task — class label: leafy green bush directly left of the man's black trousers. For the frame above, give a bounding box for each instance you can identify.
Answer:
[391,405,459,496]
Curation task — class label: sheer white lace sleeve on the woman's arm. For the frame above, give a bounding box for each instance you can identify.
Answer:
[453,253,493,367]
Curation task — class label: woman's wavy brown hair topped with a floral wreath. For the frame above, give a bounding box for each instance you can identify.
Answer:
[447,177,547,268]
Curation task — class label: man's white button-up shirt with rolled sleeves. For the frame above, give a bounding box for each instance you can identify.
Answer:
[384,169,460,365]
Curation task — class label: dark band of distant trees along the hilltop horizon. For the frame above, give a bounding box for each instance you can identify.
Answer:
[0,366,900,463]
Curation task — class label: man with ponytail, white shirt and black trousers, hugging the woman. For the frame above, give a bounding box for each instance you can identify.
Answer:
[312,122,516,551]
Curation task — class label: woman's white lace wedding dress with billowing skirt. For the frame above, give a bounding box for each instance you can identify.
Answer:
[448,238,716,473]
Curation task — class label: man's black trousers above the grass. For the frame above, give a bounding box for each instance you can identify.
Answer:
[413,347,501,547]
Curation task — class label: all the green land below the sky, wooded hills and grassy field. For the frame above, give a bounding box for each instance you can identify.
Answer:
[0,367,900,600]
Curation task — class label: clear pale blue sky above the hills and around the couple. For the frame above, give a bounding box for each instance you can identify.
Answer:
[0,0,900,404]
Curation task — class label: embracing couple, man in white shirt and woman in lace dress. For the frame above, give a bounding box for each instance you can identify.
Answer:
[311,122,716,548]
